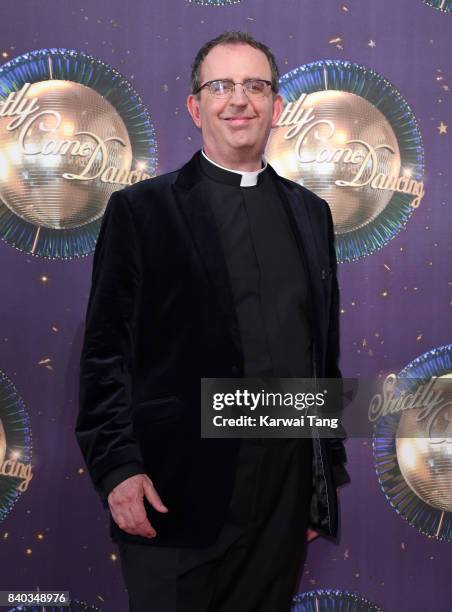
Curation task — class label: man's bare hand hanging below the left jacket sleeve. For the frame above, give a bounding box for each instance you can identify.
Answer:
[108,474,168,538]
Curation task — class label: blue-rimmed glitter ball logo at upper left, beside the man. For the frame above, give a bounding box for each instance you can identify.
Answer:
[0,49,157,259]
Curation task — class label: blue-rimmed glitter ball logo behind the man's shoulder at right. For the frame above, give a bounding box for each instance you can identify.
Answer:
[266,60,424,262]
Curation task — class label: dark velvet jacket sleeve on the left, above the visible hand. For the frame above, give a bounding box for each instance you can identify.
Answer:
[75,192,144,505]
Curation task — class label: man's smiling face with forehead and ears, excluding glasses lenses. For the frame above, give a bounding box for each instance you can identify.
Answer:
[187,43,283,167]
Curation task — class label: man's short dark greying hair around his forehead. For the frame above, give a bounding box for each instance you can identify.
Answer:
[191,32,279,93]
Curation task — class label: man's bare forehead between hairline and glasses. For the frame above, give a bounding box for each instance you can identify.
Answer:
[201,43,271,78]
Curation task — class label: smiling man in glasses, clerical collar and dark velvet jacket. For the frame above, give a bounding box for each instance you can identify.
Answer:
[76,32,349,612]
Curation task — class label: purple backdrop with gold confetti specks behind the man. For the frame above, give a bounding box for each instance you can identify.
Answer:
[0,0,452,612]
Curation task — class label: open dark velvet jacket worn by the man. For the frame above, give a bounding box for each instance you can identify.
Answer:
[76,152,350,546]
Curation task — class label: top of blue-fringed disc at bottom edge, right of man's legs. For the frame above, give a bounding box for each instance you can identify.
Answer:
[291,589,383,612]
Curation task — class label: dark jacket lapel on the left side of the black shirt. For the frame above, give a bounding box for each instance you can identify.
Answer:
[174,153,243,355]
